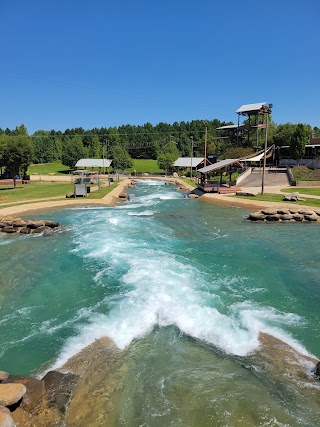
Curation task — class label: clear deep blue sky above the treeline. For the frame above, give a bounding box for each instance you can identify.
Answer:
[0,0,320,134]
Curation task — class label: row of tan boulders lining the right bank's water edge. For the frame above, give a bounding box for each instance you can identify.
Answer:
[248,207,320,224]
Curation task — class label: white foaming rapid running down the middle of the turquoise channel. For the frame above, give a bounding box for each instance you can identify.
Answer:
[51,182,312,366]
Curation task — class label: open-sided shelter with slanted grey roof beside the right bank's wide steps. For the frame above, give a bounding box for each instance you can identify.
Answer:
[198,159,242,193]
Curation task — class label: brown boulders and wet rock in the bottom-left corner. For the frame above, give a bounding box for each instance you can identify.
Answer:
[0,371,78,427]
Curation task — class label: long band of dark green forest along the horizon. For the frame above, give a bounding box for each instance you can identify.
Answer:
[0,119,320,175]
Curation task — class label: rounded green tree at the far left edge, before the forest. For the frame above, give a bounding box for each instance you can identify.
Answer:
[0,134,33,187]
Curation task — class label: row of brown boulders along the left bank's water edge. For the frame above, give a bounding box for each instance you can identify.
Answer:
[0,216,60,234]
